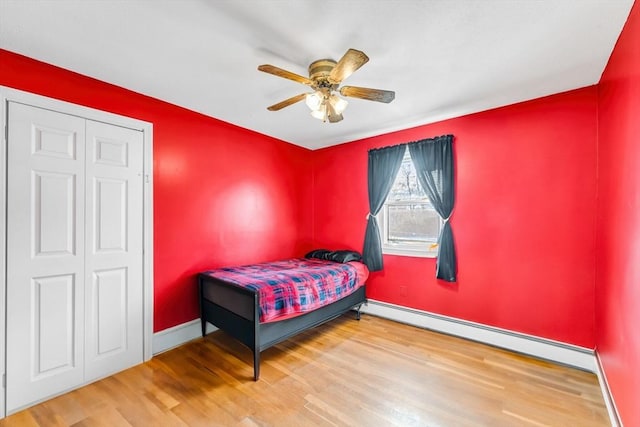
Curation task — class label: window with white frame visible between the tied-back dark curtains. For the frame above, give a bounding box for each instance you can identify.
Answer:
[378,149,442,257]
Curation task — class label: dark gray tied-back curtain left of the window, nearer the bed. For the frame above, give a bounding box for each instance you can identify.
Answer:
[362,145,407,271]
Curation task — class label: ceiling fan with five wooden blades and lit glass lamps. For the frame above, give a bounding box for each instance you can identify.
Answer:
[258,49,395,123]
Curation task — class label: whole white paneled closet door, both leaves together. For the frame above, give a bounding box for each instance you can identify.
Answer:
[6,103,144,413]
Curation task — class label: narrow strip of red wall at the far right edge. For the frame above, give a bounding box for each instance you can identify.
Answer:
[596,2,640,426]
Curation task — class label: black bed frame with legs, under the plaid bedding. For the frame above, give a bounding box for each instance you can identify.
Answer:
[198,273,366,381]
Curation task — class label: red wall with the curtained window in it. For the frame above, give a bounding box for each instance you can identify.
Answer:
[313,87,597,348]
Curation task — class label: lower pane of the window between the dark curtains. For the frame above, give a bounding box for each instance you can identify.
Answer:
[387,204,440,243]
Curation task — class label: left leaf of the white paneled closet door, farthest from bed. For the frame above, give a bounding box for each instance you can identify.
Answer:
[7,103,85,412]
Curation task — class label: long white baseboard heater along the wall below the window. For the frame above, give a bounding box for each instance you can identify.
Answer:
[362,299,597,373]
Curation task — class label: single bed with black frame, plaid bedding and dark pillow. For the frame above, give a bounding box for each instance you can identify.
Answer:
[198,251,369,381]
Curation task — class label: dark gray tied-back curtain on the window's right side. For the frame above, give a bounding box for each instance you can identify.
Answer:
[409,135,456,282]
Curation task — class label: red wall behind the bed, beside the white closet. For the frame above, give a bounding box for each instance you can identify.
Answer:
[0,50,312,331]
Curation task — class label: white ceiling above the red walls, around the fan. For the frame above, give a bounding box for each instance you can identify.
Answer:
[0,0,633,149]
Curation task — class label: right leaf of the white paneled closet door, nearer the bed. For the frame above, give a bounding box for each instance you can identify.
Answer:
[85,121,143,381]
